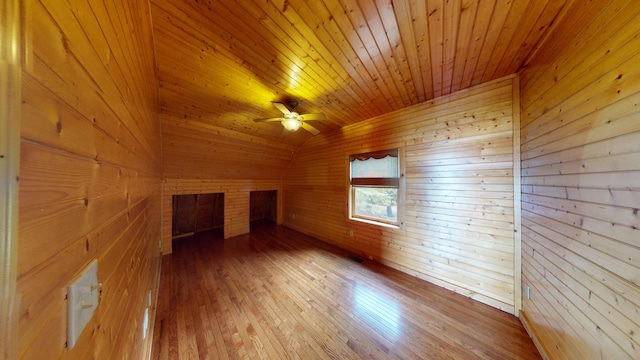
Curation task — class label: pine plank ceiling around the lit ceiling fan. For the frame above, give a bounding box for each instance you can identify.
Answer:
[151,0,579,146]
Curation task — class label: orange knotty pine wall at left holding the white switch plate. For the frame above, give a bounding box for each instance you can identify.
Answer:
[17,0,162,359]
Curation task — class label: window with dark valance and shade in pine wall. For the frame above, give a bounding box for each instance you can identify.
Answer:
[349,149,401,225]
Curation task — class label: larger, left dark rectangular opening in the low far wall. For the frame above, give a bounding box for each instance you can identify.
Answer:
[171,193,224,239]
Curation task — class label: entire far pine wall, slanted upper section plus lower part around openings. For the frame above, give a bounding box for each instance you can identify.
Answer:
[161,114,295,254]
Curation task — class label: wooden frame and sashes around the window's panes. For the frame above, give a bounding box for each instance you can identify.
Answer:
[346,145,406,229]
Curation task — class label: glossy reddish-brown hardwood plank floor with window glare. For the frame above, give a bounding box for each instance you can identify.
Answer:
[152,221,540,359]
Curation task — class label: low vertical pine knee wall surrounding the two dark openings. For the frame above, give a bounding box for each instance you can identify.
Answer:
[162,179,282,254]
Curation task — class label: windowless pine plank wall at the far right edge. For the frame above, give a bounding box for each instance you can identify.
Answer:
[521,1,640,359]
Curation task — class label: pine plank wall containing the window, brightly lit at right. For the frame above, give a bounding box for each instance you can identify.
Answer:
[283,76,517,313]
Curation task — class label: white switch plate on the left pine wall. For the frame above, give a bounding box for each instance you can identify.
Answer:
[67,260,102,349]
